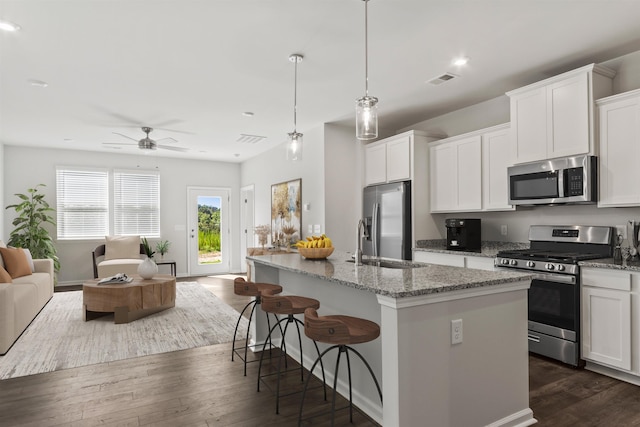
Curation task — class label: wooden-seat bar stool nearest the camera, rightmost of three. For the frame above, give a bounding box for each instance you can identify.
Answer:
[298,308,382,426]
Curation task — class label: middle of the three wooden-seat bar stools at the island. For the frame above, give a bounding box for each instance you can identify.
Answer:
[258,291,327,414]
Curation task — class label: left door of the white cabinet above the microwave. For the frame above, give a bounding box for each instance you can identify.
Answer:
[511,87,547,163]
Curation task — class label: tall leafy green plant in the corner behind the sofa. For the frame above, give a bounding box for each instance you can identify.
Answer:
[6,184,60,272]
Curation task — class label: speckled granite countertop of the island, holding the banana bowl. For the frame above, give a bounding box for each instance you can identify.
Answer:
[247,250,531,298]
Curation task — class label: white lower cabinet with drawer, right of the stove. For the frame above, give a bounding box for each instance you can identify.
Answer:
[581,268,640,375]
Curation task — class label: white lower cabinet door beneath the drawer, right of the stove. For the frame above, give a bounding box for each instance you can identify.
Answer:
[582,286,631,370]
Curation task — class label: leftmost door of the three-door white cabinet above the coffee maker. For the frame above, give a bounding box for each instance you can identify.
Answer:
[429,144,458,212]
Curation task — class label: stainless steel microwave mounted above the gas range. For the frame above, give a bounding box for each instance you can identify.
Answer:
[507,155,598,205]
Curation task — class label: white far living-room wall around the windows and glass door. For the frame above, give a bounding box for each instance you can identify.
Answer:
[2,145,244,284]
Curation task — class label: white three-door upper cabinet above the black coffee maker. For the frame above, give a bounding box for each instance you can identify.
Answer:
[429,124,513,212]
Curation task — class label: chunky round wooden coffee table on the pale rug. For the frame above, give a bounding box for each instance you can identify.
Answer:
[82,274,176,323]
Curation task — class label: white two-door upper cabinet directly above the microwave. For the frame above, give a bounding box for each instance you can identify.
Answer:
[507,64,615,163]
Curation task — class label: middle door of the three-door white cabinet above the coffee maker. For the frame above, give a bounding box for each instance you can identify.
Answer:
[455,136,482,211]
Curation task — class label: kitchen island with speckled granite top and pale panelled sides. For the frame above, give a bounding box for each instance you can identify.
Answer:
[247,251,536,427]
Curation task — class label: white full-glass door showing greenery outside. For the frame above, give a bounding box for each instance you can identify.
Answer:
[187,187,230,276]
